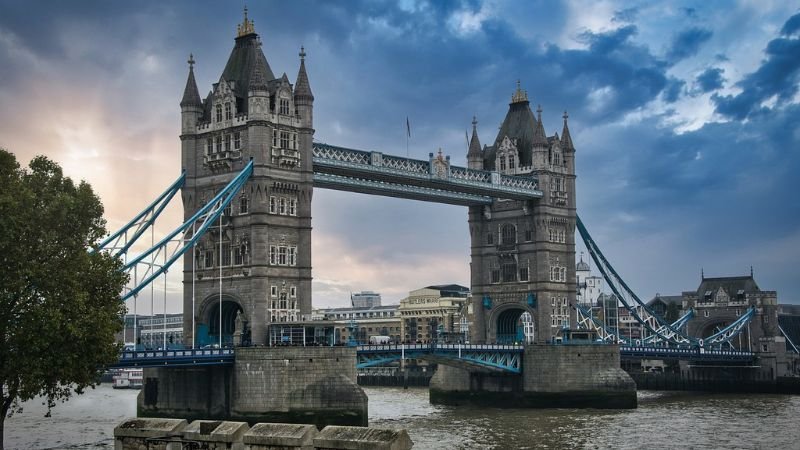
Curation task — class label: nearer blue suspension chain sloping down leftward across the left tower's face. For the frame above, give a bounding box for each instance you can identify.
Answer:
[122,161,253,300]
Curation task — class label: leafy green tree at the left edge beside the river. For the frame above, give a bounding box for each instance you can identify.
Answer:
[0,148,127,450]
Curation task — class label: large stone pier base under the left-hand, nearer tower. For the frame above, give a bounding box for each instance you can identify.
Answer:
[137,347,367,428]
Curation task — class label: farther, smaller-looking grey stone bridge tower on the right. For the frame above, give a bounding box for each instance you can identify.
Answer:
[467,83,576,343]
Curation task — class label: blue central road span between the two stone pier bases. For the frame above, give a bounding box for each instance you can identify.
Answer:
[356,344,524,373]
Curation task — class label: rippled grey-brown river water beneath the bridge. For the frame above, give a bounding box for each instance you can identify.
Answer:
[5,384,800,449]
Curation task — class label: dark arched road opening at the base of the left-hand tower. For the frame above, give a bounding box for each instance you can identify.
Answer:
[196,294,249,347]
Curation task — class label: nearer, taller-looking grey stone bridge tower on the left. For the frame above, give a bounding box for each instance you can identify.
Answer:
[180,8,314,345]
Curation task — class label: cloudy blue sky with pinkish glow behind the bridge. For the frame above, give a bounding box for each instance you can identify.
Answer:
[0,0,800,311]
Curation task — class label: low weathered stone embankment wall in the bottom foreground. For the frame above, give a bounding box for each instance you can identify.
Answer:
[114,418,414,450]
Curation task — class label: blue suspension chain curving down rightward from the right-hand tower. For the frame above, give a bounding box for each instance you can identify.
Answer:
[576,215,755,347]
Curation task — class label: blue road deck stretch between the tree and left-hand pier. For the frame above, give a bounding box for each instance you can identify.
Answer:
[109,348,234,369]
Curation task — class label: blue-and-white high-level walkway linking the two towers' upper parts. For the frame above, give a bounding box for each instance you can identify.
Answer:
[313,142,543,206]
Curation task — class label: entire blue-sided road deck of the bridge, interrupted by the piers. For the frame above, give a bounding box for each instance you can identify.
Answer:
[111,344,755,373]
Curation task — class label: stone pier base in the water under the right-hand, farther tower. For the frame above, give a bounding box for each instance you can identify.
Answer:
[430,345,637,409]
